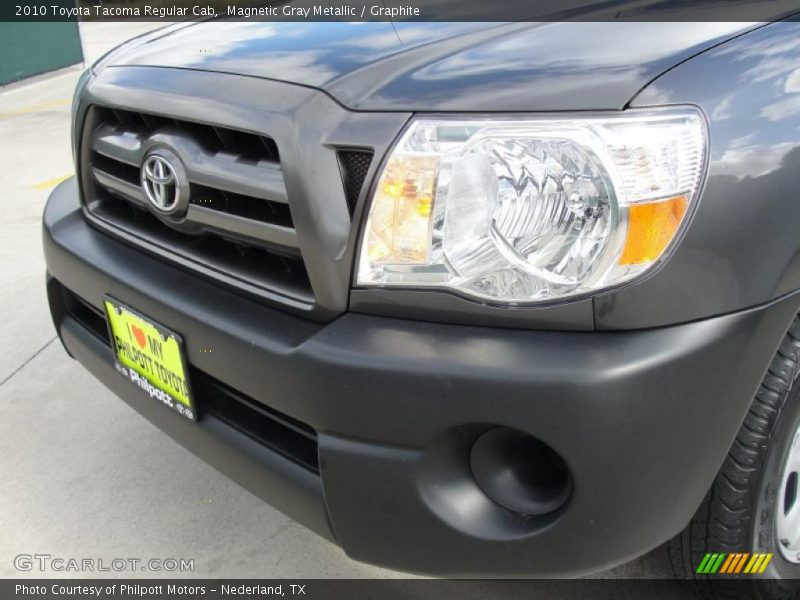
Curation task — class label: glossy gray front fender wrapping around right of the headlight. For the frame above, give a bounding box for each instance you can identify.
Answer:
[595,21,800,329]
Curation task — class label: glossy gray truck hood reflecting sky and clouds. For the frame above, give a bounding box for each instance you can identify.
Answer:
[106,21,754,111]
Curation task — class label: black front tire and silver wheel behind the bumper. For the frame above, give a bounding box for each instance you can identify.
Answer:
[669,317,800,600]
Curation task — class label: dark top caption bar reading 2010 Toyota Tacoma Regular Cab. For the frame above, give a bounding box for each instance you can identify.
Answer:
[0,0,800,23]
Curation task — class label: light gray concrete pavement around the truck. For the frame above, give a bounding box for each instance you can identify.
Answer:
[0,23,680,578]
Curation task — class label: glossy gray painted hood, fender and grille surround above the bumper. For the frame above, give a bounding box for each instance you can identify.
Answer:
[78,17,800,330]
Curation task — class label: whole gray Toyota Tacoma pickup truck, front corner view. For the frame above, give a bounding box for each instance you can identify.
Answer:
[44,20,800,598]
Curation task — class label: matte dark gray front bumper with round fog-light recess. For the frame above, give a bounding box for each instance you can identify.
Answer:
[44,181,798,576]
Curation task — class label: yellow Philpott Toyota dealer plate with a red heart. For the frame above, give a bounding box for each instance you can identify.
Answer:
[105,297,197,421]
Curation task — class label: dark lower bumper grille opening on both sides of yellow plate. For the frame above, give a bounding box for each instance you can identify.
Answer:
[58,284,319,473]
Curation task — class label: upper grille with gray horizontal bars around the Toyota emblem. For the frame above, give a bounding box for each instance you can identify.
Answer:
[82,106,314,308]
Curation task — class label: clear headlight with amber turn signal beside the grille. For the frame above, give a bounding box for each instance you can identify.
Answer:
[357,108,707,304]
